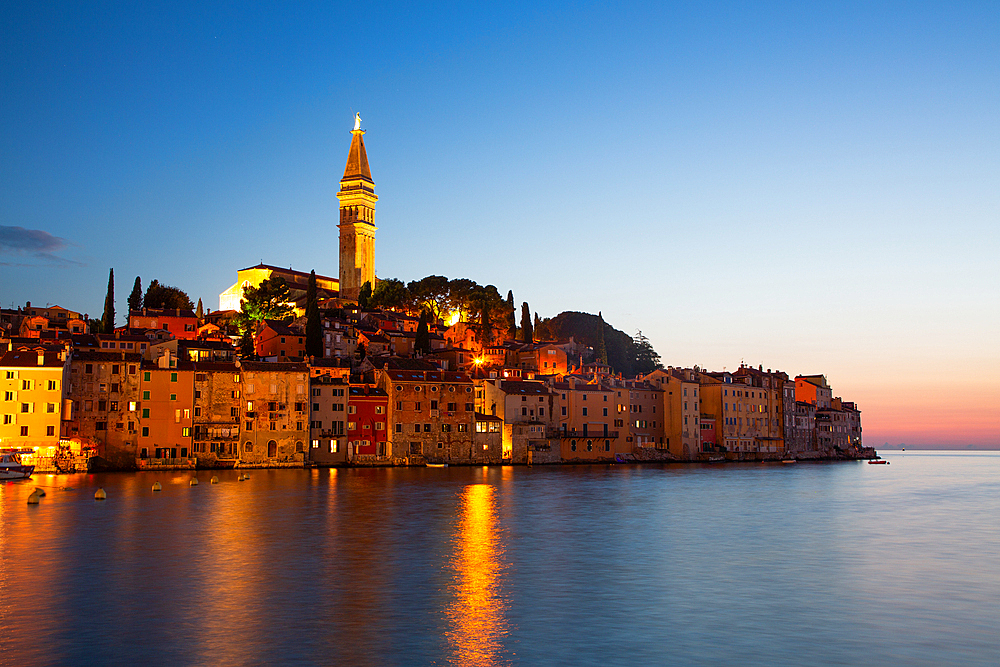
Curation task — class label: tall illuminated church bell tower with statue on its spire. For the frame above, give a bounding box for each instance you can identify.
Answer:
[337,114,378,301]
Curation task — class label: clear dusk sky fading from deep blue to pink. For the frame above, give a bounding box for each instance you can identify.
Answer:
[0,1,1000,448]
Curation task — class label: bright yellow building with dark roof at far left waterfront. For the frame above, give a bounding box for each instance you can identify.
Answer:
[0,349,69,448]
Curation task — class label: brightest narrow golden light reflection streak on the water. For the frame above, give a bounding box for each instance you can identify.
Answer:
[445,484,509,665]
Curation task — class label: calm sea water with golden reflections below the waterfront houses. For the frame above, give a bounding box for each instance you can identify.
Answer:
[0,452,1000,666]
